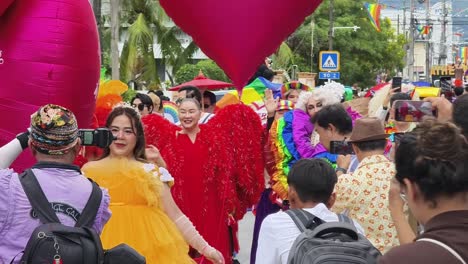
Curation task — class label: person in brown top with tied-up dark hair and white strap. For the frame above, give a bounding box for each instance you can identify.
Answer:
[379,120,468,264]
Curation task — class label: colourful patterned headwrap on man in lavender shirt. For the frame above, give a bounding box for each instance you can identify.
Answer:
[31,104,78,155]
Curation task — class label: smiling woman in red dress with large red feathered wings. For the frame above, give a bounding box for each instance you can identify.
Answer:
[142,98,264,263]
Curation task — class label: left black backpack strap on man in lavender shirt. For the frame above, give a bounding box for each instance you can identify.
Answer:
[19,169,60,224]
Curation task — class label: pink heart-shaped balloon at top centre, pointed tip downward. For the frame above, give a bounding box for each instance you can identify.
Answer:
[159,0,322,90]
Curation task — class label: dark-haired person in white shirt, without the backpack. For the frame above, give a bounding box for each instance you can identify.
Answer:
[256,159,364,264]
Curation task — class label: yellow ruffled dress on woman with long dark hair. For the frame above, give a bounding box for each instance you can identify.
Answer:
[82,158,194,264]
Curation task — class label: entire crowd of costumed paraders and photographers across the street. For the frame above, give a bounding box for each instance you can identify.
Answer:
[0,69,468,264]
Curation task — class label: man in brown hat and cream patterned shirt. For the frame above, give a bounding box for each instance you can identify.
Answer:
[333,117,399,252]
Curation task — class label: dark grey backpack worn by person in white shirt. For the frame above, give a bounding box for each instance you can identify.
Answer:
[286,209,381,264]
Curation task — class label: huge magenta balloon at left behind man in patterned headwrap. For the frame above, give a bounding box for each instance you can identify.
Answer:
[0,0,100,170]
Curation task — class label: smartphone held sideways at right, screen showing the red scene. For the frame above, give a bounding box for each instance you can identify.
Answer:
[394,100,437,122]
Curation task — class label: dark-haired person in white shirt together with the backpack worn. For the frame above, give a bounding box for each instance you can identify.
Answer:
[256,159,378,264]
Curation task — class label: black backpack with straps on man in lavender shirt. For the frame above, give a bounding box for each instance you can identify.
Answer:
[12,169,104,264]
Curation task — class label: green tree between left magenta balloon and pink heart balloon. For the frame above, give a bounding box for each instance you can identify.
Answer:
[100,0,198,87]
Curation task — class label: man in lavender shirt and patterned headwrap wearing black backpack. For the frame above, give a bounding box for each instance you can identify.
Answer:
[0,104,111,263]
